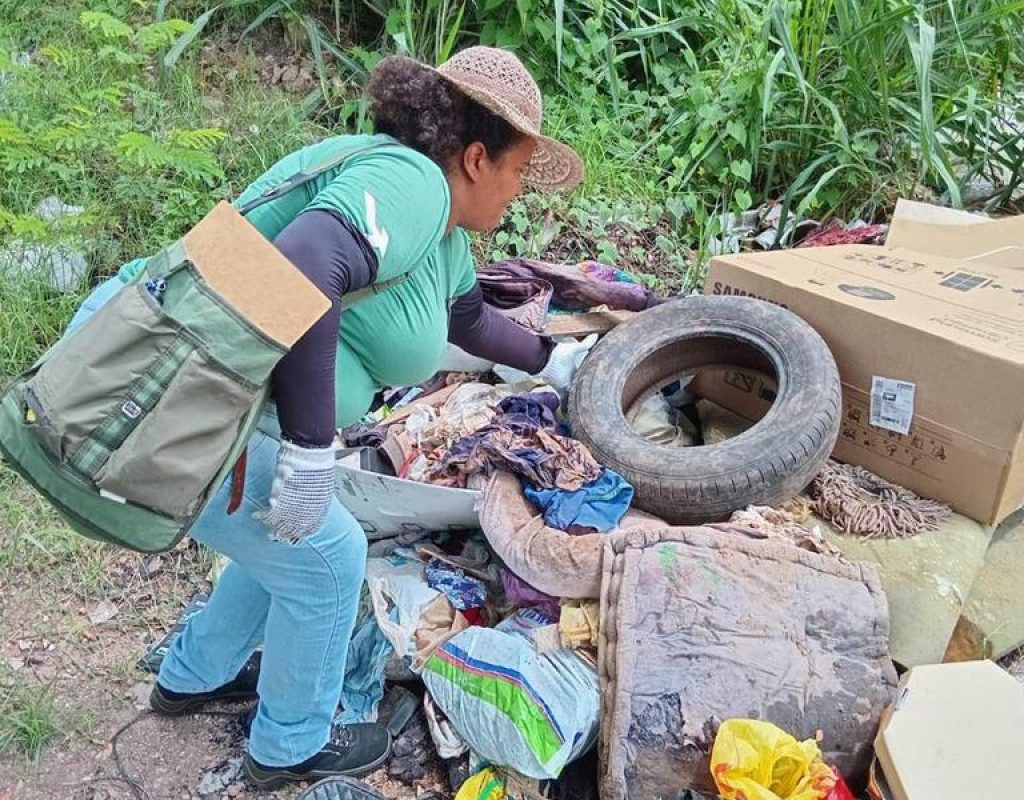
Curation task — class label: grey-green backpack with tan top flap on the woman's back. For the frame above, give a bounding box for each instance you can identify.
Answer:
[0,144,409,552]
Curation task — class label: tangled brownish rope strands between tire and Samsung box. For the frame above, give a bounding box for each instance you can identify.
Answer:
[811,461,951,539]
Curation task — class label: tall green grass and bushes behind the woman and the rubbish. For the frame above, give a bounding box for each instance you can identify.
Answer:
[0,0,1024,372]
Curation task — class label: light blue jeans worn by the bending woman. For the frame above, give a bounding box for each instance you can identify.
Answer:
[66,279,367,766]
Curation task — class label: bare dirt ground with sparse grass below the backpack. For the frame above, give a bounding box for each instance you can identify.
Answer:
[0,477,445,800]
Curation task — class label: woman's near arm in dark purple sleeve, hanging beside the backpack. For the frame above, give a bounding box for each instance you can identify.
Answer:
[272,210,377,448]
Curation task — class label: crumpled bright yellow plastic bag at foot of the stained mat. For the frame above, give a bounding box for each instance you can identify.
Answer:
[711,719,836,800]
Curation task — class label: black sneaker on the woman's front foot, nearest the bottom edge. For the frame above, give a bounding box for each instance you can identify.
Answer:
[244,722,391,790]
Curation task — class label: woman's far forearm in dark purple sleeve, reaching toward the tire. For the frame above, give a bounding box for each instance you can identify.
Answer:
[449,284,554,375]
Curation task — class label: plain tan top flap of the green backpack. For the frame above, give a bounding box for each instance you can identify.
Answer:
[184,202,331,347]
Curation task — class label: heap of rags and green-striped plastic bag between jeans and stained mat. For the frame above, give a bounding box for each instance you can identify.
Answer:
[348,533,600,790]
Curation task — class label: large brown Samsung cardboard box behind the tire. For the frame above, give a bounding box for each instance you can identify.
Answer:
[695,204,1024,523]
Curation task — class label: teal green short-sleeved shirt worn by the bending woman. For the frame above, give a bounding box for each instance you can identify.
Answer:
[120,135,475,426]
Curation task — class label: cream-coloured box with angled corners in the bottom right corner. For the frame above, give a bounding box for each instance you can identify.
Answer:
[874,661,1024,800]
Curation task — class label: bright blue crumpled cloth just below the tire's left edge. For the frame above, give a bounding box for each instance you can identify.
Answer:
[523,469,633,534]
